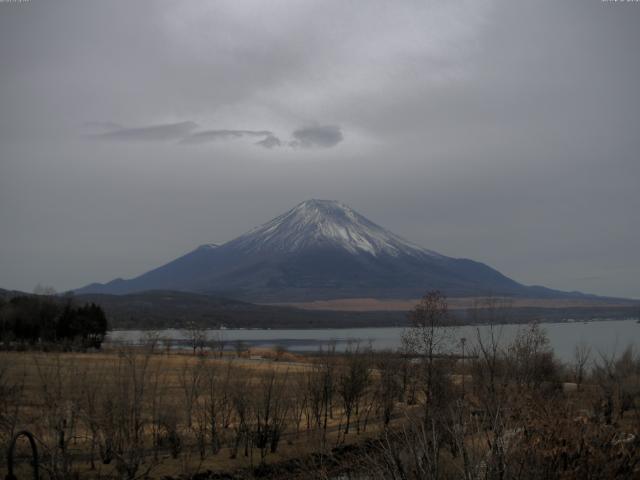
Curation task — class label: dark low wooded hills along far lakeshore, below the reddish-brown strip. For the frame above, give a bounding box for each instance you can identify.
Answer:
[78,292,640,329]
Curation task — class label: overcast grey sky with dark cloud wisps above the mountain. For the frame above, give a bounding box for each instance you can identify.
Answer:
[0,0,640,298]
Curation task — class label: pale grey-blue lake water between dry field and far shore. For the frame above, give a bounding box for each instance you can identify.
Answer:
[106,319,640,362]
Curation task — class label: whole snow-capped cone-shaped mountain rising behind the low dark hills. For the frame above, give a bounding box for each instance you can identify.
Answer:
[76,200,580,302]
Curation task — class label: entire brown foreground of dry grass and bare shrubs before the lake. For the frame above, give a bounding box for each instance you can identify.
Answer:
[0,317,640,480]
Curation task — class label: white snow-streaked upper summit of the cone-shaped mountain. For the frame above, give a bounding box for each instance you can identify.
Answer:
[230,199,438,256]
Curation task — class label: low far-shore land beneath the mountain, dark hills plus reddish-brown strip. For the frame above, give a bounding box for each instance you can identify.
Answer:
[0,289,640,330]
